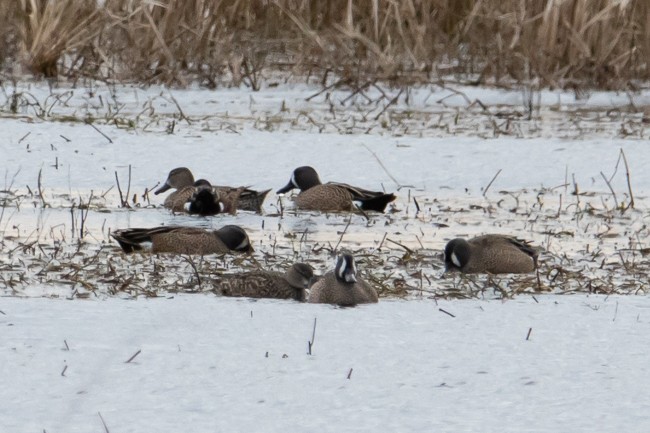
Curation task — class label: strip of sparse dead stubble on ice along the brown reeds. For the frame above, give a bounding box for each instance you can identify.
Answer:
[0,81,650,141]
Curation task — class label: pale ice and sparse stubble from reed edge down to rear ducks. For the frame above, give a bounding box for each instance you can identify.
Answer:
[0,84,650,200]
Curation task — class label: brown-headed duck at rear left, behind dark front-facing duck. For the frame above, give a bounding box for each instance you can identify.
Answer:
[155,167,271,213]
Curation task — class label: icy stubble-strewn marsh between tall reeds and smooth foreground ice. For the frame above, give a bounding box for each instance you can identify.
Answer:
[0,81,650,297]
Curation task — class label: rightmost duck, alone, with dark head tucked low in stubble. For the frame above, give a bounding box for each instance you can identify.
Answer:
[445,235,538,274]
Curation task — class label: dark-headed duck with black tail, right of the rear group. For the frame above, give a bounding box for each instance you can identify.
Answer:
[277,166,395,212]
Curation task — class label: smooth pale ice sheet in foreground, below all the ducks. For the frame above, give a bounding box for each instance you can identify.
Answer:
[0,295,650,433]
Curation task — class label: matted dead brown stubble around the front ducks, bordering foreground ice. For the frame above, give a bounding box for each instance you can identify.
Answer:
[0,182,650,299]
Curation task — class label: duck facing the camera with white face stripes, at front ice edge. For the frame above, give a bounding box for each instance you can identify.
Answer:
[309,253,379,306]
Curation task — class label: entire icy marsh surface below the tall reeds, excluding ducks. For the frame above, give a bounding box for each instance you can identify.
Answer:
[0,80,650,433]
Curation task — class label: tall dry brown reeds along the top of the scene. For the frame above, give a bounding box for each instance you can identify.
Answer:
[0,0,650,89]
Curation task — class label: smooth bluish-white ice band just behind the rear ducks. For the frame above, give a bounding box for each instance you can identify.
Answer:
[0,123,650,196]
